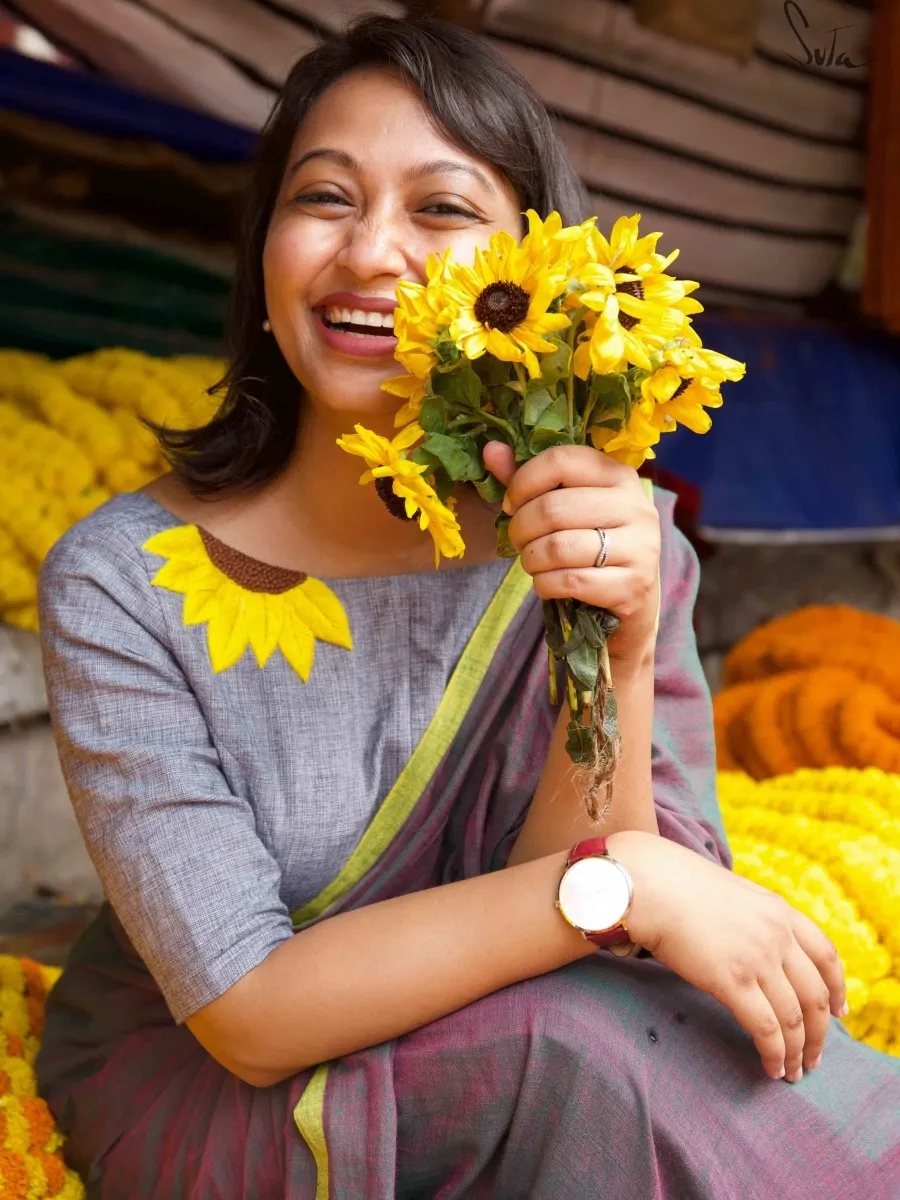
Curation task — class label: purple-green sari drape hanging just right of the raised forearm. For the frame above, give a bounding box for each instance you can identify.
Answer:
[653,491,731,866]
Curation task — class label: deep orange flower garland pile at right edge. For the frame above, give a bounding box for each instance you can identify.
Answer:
[714,605,900,779]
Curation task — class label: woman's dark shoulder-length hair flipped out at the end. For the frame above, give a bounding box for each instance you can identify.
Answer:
[155,16,587,496]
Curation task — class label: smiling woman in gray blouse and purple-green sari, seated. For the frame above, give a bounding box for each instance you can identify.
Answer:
[38,11,900,1200]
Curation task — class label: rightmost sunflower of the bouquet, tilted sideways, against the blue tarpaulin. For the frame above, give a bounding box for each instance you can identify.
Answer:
[641,338,746,433]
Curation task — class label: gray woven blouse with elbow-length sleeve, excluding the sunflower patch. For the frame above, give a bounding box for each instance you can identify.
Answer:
[41,492,509,1022]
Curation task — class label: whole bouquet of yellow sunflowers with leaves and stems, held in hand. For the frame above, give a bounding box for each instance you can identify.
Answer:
[338,211,744,816]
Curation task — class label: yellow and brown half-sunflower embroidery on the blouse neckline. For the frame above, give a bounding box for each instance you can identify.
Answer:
[144,526,353,683]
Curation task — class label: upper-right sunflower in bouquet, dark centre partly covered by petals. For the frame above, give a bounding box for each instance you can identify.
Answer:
[578,214,703,378]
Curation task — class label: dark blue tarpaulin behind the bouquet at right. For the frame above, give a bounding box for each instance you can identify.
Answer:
[656,316,900,541]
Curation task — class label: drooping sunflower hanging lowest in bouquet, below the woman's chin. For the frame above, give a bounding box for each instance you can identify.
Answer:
[337,424,466,566]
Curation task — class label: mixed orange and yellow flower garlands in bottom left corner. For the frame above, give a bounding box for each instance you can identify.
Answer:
[0,955,85,1200]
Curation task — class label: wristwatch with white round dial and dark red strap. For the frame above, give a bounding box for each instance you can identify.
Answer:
[556,838,638,958]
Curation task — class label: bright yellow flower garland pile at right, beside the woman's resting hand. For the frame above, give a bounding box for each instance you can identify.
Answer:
[719,767,900,1056]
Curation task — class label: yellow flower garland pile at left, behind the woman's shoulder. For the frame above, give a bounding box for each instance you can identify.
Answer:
[0,349,223,629]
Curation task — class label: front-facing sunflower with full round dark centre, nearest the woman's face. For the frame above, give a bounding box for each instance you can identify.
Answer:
[442,223,569,379]
